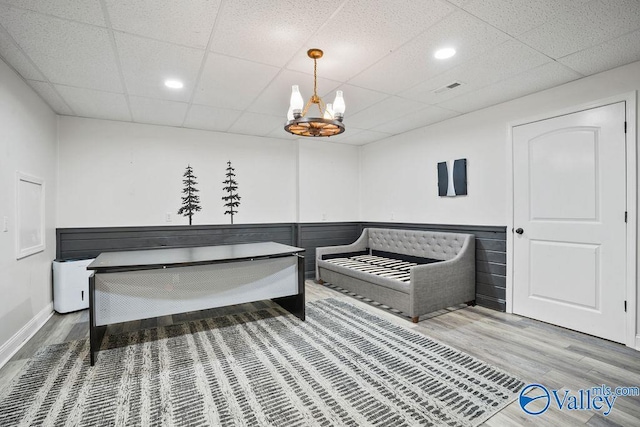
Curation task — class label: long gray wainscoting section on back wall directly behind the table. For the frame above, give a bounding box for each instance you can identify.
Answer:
[56,223,297,259]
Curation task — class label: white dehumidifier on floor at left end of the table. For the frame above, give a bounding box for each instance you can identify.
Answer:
[53,258,94,313]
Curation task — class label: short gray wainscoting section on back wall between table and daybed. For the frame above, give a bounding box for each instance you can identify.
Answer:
[296,222,362,279]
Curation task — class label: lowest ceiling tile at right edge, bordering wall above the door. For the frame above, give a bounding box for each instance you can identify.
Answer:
[558,31,640,76]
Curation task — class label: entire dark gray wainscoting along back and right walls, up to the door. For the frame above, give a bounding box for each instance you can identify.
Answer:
[56,222,507,311]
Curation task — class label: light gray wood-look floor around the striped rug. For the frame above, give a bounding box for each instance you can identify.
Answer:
[0,281,640,427]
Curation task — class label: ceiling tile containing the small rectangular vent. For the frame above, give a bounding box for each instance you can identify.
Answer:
[400,40,551,104]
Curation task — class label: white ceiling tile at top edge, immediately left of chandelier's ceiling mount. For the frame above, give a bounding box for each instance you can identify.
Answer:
[211,0,343,67]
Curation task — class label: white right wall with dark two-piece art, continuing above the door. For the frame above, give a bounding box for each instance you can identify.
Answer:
[360,62,640,342]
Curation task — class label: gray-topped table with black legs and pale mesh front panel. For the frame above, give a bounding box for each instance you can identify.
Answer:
[87,242,305,366]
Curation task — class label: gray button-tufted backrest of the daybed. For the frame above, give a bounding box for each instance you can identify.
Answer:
[367,228,473,261]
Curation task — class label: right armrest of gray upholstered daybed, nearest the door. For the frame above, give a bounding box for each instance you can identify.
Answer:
[410,235,475,316]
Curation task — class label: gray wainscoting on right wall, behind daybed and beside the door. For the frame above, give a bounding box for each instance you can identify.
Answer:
[362,222,507,311]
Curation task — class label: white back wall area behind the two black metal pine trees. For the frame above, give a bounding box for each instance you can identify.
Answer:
[58,117,297,227]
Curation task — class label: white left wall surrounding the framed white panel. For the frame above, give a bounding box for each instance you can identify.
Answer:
[0,60,57,366]
